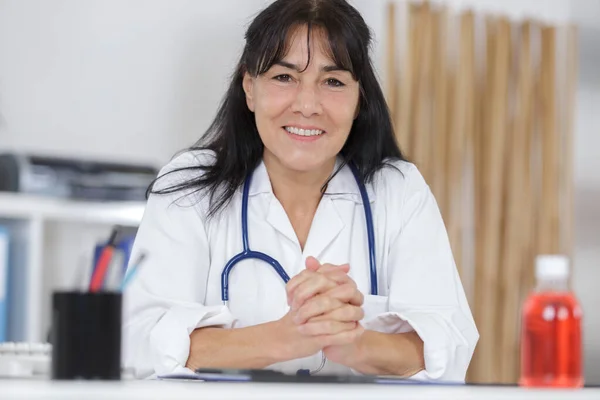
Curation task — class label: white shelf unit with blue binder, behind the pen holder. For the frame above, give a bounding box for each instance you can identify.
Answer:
[0,192,145,342]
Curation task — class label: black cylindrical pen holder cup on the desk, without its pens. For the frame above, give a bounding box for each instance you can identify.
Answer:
[51,292,122,380]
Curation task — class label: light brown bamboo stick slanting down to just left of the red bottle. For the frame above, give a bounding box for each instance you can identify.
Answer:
[499,22,534,383]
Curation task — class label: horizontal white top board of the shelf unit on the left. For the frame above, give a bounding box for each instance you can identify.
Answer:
[0,193,145,226]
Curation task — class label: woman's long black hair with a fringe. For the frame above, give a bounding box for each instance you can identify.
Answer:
[148,0,404,216]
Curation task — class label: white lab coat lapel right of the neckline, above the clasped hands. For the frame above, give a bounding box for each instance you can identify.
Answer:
[303,195,344,260]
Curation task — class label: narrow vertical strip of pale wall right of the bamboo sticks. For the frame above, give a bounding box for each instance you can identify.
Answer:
[573,0,600,383]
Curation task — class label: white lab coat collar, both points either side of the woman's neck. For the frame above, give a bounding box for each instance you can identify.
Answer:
[249,157,375,204]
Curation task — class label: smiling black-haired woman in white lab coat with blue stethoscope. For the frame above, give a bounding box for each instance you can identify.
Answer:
[124,0,478,381]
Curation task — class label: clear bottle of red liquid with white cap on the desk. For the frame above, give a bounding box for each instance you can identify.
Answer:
[519,255,584,388]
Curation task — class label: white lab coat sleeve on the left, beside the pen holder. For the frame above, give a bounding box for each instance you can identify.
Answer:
[123,154,234,378]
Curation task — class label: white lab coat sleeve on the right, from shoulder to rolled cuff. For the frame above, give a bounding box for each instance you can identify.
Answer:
[364,165,479,382]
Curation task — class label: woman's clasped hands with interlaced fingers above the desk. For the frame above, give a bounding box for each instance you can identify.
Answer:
[280,257,364,363]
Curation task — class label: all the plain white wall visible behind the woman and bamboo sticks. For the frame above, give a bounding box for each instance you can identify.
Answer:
[0,0,600,383]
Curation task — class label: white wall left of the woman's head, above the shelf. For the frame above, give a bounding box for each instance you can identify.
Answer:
[0,0,263,163]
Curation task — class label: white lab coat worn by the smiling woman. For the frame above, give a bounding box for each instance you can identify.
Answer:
[123,152,479,381]
